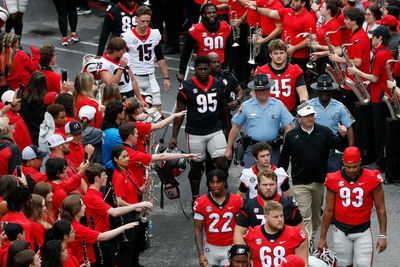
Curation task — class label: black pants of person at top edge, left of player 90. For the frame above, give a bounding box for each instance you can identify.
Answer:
[150,0,183,49]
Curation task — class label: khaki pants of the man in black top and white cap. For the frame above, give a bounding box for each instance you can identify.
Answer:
[293,183,325,239]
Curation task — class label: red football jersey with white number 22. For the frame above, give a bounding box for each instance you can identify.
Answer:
[193,193,243,246]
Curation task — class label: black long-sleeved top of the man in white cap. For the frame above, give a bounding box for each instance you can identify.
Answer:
[279,123,339,185]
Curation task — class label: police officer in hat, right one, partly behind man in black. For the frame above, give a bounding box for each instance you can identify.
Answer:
[309,74,355,172]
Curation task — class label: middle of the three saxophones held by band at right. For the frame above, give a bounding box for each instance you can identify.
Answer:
[342,40,371,105]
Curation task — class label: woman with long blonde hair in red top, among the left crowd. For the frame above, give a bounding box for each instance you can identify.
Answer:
[73,72,104,128]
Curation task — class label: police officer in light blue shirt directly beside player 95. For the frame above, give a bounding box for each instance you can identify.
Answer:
[225,74,294,168]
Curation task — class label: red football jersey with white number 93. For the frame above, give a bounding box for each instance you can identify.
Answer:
[325,169,383,225]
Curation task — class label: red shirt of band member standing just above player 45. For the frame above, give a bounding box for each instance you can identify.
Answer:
[278,8,316,58]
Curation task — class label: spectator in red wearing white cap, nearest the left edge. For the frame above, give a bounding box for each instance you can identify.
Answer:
[1,90,32,151]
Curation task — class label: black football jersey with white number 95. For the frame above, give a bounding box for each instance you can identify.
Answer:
[177,76,225,135]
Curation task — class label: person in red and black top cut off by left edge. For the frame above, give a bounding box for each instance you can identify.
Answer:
[0,117,22,175]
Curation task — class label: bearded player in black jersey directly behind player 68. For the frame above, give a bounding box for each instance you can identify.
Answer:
[233,169,306,244]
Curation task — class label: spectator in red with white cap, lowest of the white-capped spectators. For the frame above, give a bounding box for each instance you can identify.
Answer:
[21,145,47,183]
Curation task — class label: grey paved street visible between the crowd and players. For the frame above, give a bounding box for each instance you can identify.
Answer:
[22,0,400,267]
